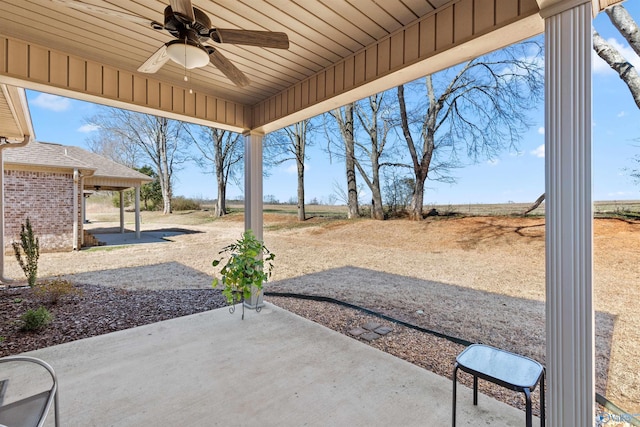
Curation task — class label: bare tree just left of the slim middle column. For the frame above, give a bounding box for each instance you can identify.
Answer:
[187,126,244,217]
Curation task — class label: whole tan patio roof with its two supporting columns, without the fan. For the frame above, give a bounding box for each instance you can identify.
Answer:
[0,0,632,426]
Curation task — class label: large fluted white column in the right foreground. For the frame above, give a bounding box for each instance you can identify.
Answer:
[541,0,595,427]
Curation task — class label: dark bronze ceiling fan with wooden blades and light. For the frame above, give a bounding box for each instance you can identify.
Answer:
[52,0,289,87]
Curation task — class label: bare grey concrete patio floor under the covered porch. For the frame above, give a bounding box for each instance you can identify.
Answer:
[7,304,537,427]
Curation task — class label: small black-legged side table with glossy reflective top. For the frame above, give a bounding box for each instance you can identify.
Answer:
[452,344,545,427]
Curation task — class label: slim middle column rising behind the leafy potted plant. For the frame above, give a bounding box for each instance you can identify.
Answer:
[244,132,264,308]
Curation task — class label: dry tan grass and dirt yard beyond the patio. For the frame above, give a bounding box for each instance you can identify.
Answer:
[5,207,640,413]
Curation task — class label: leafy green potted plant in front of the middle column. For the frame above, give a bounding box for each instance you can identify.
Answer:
[211,230,275,319]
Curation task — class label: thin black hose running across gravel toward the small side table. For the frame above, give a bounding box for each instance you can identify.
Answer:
[264,292,640,427]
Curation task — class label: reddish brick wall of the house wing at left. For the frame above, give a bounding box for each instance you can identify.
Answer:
[4,170,82,253]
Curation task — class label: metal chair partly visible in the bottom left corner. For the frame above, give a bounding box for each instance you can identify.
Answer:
[0,356,60,427]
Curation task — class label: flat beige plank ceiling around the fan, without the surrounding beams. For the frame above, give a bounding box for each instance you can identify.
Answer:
[0,0,449,105]
